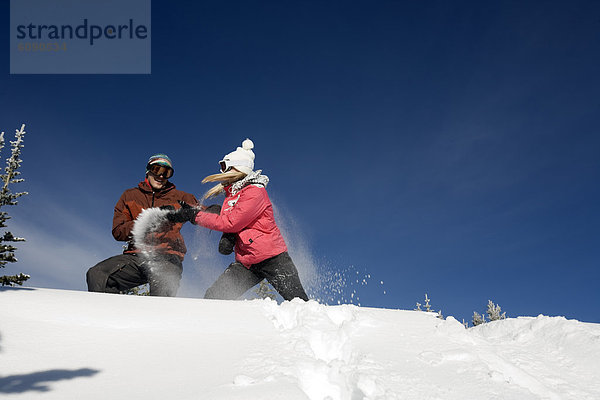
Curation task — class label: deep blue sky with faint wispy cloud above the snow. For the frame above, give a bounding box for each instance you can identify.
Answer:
[0,0,600,322]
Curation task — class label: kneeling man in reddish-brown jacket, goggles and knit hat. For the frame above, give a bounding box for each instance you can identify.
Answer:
[86,154,198,296]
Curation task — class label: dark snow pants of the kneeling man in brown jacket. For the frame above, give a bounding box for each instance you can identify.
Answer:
[86,254,183,296]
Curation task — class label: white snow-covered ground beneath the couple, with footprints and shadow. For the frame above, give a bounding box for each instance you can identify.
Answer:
[0,288,600,400]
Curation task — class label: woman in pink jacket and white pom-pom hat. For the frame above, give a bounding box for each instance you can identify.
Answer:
[167,139,308,301]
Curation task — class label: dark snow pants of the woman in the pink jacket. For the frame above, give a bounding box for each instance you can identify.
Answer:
[204,252,308,301]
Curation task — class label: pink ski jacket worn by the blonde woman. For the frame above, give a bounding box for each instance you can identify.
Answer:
[196,185,287,268]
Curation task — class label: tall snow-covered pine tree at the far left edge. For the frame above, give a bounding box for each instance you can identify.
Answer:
[0,124,30,286]
